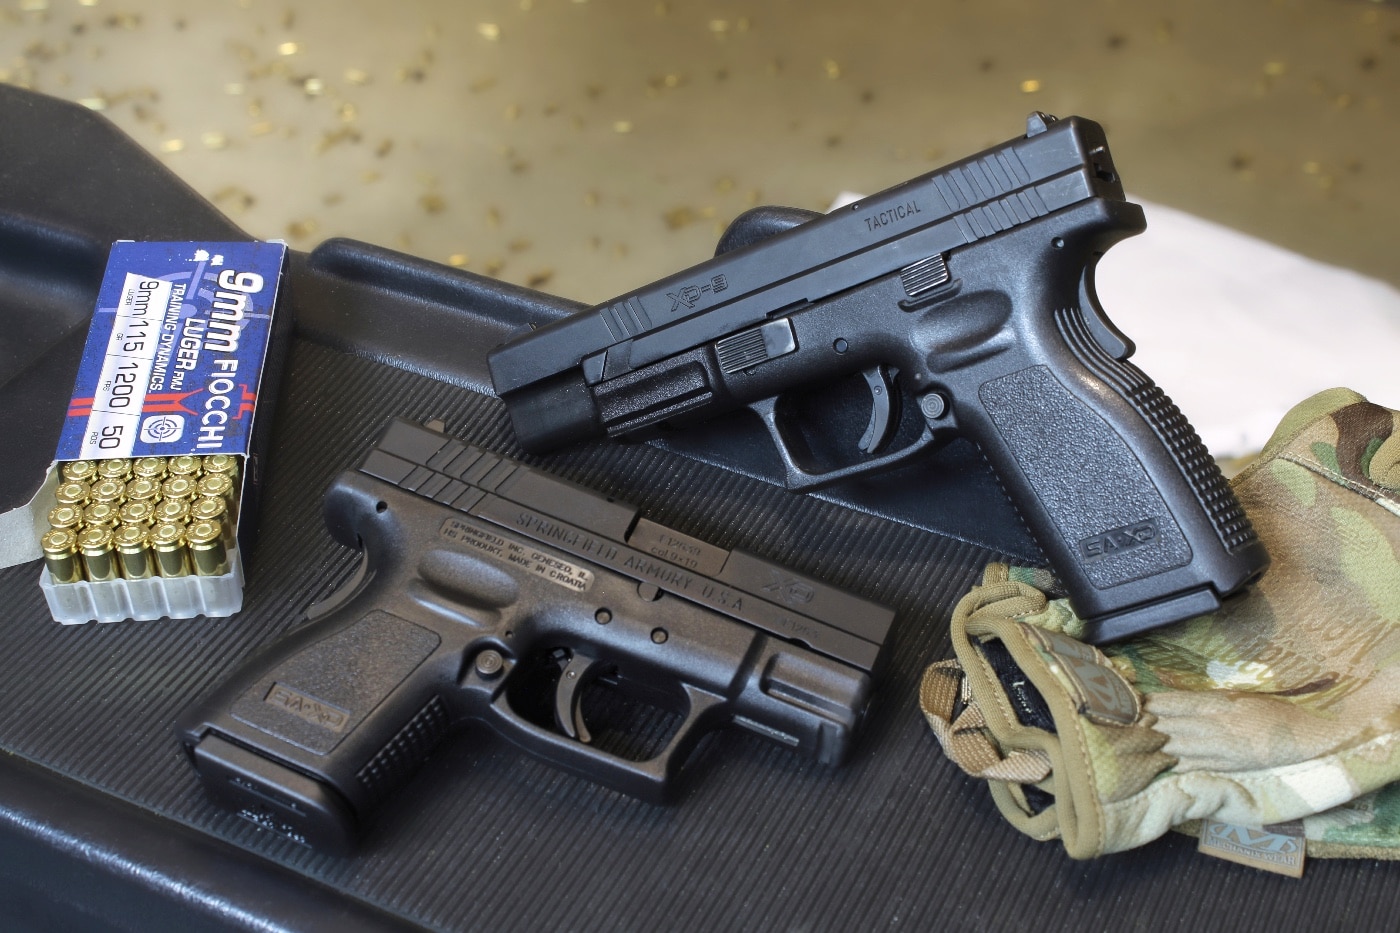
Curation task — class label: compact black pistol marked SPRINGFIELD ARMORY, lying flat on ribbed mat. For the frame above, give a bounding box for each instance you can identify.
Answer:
[178,420,893,852]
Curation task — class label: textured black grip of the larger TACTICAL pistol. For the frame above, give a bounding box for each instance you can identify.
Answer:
[967,322,1268,643]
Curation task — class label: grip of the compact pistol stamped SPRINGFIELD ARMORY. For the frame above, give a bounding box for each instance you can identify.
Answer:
[179,607,451,852]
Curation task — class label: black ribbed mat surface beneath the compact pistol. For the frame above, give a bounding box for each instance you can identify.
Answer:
[0,342,1377,933]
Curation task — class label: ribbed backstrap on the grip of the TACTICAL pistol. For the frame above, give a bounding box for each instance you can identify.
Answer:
[1056,308,1259,551]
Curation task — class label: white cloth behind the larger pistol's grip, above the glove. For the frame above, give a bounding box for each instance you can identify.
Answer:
[1096,202,1400,457]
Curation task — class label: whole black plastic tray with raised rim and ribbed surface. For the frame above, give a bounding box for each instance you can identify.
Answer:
[0,84,1400,933]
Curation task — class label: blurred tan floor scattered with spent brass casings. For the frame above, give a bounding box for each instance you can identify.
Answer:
[0,0,1400,301]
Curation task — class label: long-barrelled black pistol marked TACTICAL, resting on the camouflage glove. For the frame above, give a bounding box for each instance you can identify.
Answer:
[490,113,1268,642]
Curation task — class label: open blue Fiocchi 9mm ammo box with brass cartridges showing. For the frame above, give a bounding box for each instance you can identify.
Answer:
[39,241,287,623]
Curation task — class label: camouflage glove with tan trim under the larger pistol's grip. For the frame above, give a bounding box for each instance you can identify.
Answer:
[920,389,1400,859]
